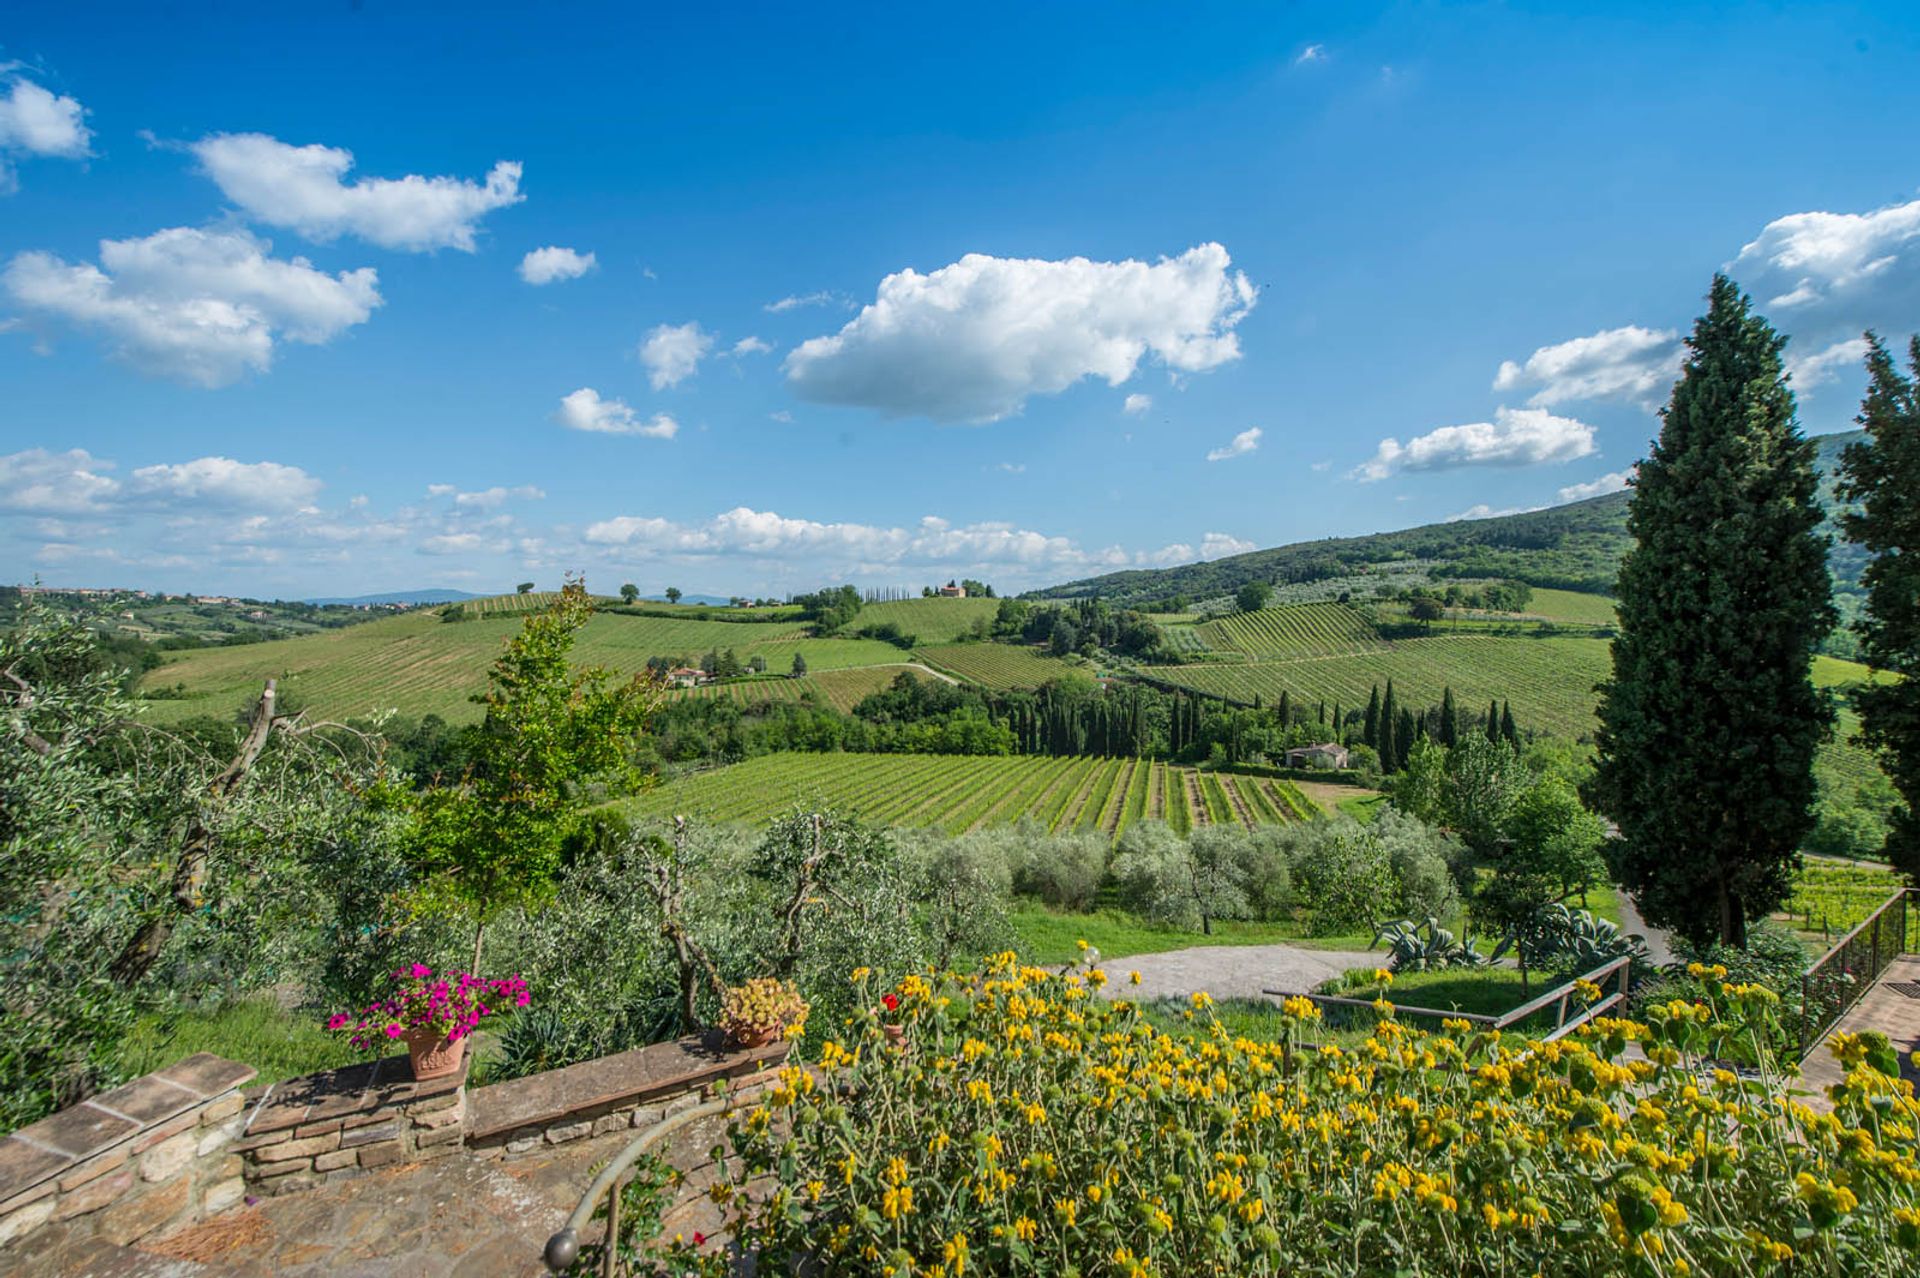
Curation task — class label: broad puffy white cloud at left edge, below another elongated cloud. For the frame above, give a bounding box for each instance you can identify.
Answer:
[0,226,380,386]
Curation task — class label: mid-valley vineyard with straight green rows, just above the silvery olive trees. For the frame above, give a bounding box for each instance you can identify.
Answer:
[628,754,1319,837]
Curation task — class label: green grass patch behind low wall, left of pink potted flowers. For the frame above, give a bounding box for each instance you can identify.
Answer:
[121,998,365,1082]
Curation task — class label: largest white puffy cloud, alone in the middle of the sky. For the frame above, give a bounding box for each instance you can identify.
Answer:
[783,244,1256,422]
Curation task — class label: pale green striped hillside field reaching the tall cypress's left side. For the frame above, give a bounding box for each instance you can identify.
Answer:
[1152,635,1611,737]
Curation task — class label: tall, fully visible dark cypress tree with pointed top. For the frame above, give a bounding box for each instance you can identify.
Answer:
[1588,276,1834,946]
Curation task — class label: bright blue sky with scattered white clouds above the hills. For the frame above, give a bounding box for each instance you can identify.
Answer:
[0,0,1920,597]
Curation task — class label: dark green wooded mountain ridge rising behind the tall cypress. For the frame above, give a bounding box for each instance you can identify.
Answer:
[1025,430,1866,612]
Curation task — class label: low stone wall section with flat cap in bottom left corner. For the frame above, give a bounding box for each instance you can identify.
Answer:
[0,1052,255,1245]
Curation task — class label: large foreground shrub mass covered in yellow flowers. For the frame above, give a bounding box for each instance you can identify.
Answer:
[676,956,1920,1278]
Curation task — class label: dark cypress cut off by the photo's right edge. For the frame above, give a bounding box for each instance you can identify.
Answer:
[1839,334,1920,877]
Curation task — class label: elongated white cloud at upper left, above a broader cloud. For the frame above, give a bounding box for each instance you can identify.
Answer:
[190,132,524,253]
